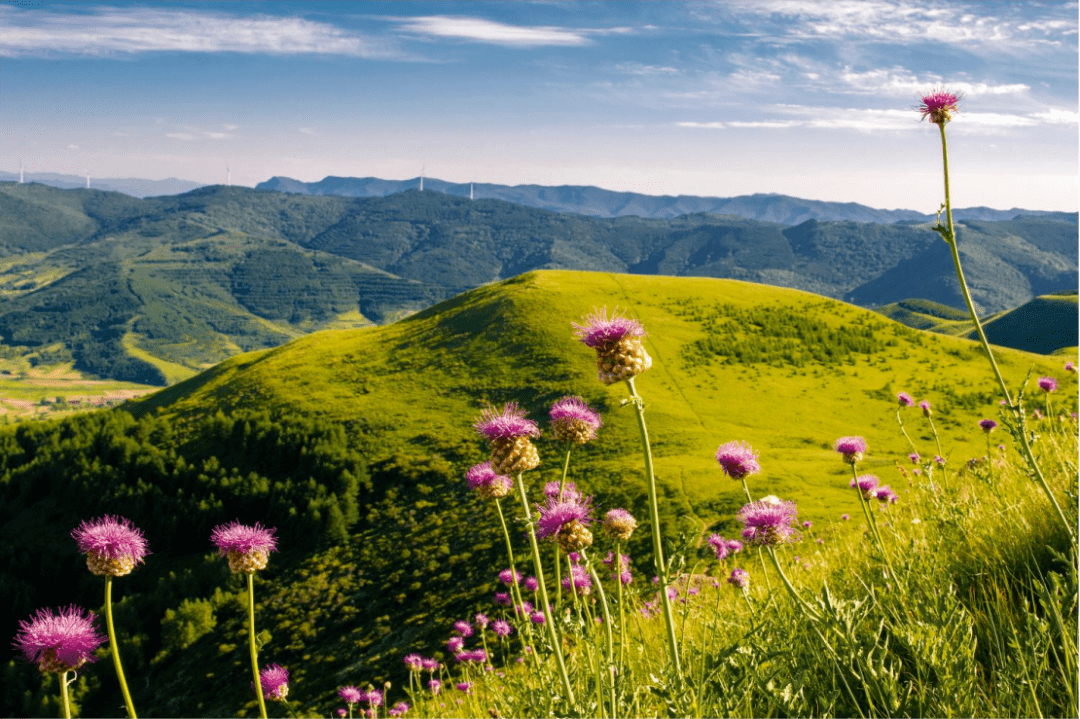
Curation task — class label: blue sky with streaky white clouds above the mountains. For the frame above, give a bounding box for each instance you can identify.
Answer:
[0,0,1078,212]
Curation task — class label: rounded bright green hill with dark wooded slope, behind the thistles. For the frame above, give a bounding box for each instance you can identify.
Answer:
[0,271,1076,716]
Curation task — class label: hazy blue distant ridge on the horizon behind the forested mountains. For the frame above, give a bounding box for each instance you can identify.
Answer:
[255,177,1077,226]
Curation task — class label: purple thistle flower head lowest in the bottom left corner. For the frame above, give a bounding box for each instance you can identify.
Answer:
[14,605,108,673]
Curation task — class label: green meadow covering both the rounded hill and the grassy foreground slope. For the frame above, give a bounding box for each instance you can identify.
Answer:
[0,271,1077,716]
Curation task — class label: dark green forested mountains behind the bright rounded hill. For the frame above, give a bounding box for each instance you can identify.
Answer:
[0,182,1078,384]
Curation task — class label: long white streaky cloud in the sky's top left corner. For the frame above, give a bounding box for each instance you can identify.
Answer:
[0,5,403,58]
